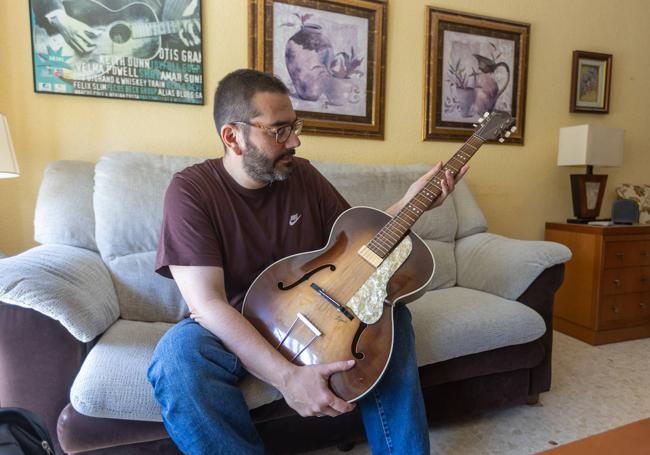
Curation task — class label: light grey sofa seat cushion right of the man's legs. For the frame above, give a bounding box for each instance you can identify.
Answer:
[409,286,546,366]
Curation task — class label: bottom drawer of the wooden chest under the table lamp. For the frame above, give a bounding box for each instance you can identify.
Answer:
[599,292,650,325]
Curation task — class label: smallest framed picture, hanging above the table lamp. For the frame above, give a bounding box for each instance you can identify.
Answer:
[570,51,612,114]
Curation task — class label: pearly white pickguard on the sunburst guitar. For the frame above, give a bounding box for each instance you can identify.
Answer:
[346,236,413,324]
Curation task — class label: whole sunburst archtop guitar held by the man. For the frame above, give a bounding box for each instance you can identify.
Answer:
[242,111,515,402]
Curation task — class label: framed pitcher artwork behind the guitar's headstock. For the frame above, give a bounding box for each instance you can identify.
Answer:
[423,7,530,144]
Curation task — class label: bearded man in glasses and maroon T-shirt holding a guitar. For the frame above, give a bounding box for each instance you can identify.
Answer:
[149,70,467,454]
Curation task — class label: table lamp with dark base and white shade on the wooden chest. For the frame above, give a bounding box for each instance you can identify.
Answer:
[557,125,625,223]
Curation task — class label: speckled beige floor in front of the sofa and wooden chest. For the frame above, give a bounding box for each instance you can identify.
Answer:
[312,332,650,455]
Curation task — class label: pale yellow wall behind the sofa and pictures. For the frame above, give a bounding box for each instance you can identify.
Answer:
[0,0,650,254]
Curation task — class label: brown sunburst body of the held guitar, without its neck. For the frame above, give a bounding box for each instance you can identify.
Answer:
[242,207,434,401]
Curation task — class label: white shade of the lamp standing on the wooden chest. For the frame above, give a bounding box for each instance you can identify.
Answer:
[557,125,625,166]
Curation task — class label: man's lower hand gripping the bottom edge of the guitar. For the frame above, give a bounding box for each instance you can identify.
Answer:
[279,360,355,417]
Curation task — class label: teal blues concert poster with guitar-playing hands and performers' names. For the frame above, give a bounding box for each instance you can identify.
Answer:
[29,0,203,104]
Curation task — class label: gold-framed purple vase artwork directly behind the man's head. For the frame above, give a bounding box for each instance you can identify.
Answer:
[249,0,386,139]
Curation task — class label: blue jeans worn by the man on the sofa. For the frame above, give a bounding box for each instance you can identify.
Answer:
[148,306,429,455]
